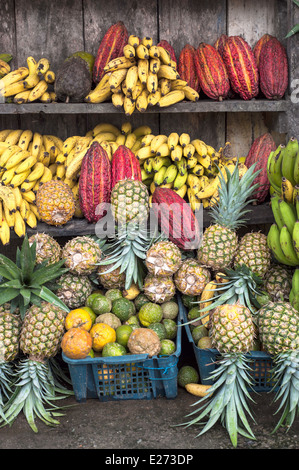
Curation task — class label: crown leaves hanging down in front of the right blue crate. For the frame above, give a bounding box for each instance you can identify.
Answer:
[180,353,255,447]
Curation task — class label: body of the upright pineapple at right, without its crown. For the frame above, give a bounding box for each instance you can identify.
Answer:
[197,224,238,271]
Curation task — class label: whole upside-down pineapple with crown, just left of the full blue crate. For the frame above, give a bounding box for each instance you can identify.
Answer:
[4,302,69,432]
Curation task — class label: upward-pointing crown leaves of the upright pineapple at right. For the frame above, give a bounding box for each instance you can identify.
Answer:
[210,160,261,230]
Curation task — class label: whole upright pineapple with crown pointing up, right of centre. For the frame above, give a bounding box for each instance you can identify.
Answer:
[197,165,257,271]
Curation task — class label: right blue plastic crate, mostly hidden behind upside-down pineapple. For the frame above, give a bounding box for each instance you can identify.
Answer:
[183,305,275,392]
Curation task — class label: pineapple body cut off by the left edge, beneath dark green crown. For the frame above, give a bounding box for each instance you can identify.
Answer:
[0,310,21,362]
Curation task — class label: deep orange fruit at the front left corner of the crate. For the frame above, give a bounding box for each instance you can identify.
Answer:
[61,328,92,359]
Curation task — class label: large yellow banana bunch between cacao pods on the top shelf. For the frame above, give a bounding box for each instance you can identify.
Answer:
[84,35,199,112]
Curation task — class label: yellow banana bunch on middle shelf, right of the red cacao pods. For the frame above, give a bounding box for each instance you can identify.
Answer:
[135,132,247,211]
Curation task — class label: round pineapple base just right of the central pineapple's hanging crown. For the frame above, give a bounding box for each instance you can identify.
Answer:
[145,240,182,277]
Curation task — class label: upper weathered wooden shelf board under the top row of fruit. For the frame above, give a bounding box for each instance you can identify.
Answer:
[0,99,288,115]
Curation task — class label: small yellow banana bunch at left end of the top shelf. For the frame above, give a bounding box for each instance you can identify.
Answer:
[0,56,56,104]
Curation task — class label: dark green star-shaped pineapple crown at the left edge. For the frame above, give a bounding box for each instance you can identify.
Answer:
[0,235,69,318]
